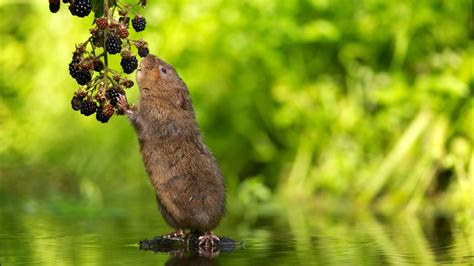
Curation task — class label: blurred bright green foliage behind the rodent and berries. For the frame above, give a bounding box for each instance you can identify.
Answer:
[0,0,474,224]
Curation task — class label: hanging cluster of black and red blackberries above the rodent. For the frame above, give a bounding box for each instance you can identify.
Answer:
[49,0,149,123]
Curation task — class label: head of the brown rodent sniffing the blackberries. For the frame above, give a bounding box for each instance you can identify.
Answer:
[137,54,189,101]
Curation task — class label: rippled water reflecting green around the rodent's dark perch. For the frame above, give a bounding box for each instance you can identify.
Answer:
[0,201,474,265]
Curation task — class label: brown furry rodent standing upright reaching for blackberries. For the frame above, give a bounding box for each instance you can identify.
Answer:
[118,55,225,245]
